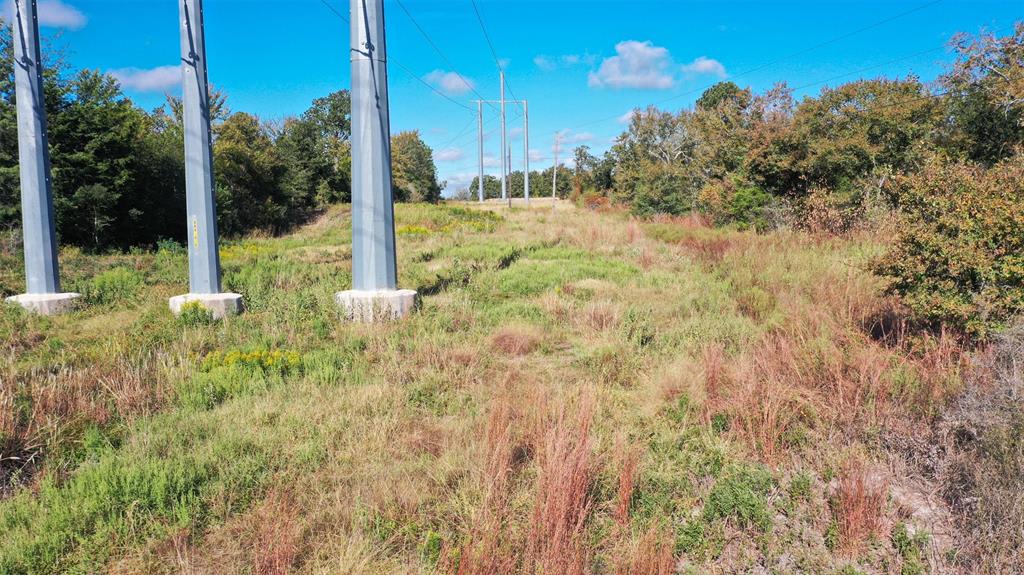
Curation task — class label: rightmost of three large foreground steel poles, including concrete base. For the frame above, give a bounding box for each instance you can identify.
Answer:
[336,0,417,322]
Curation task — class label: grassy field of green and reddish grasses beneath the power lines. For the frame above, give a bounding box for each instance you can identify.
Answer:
[0,201,991,575]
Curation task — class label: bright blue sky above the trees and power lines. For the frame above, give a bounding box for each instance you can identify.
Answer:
[9,0,1024,192]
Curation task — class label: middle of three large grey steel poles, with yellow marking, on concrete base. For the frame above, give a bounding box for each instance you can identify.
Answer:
[170,0,243,318]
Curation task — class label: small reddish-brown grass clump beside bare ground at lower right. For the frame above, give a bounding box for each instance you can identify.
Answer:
[833,459,889,552]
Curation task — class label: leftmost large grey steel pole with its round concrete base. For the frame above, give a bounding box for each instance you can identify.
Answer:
[8,0,78,315]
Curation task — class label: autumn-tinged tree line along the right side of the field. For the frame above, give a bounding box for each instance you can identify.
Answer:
[570,23,1024,337]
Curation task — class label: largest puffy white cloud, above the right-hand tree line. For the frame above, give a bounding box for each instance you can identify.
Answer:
[588,40,676,90]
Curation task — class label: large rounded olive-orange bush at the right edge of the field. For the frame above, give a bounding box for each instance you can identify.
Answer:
[877,152,1024,339]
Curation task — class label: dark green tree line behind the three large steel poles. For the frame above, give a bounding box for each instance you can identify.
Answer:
[0,19,442,251]
